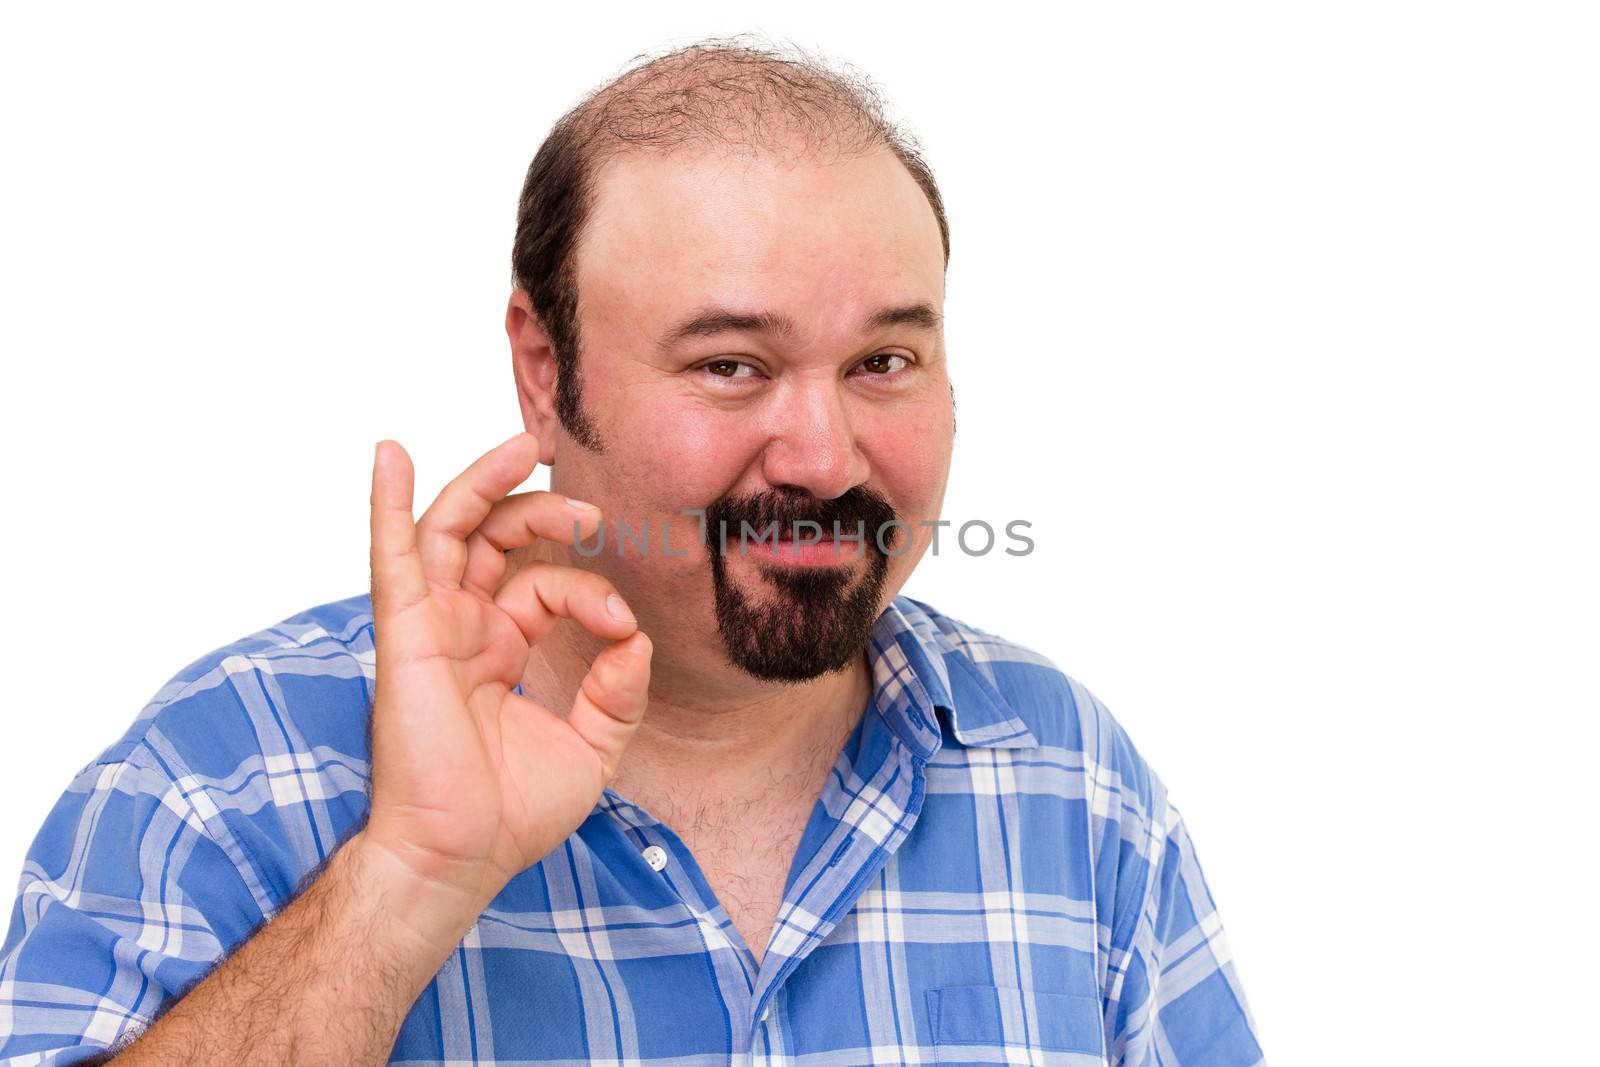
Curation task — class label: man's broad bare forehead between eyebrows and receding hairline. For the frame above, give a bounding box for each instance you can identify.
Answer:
[576,149,944,325]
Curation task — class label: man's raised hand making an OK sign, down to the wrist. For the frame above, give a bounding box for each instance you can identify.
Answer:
[360,434,651,944]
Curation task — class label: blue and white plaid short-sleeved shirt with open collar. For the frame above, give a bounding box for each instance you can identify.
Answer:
[0,595,1261,1067]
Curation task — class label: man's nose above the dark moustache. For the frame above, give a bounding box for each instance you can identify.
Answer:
[762,374,870,501]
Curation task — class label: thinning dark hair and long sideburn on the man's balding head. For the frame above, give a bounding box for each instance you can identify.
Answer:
[510,34,950,450]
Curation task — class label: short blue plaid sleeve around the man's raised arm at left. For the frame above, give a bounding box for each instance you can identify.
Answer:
[0,744,264,1067]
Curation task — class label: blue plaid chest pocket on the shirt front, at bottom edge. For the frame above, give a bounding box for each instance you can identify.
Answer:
[928,985,1106,1064]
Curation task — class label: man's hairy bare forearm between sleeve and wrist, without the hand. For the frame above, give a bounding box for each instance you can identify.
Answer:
[112,833,480,1067]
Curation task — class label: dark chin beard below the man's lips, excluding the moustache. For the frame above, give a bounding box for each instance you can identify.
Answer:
[710,550,890,681]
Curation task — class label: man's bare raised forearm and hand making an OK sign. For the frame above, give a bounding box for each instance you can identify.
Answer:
[101,434,651,1067]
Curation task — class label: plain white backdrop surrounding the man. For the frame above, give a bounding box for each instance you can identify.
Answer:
[0,2,1600,1065]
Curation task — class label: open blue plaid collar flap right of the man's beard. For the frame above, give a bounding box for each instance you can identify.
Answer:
[870,597,1038,760]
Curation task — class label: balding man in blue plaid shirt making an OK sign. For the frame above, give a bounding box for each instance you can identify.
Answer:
[0,42,1261,1067]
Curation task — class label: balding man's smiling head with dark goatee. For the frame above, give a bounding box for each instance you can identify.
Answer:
[506,42,954,681]
